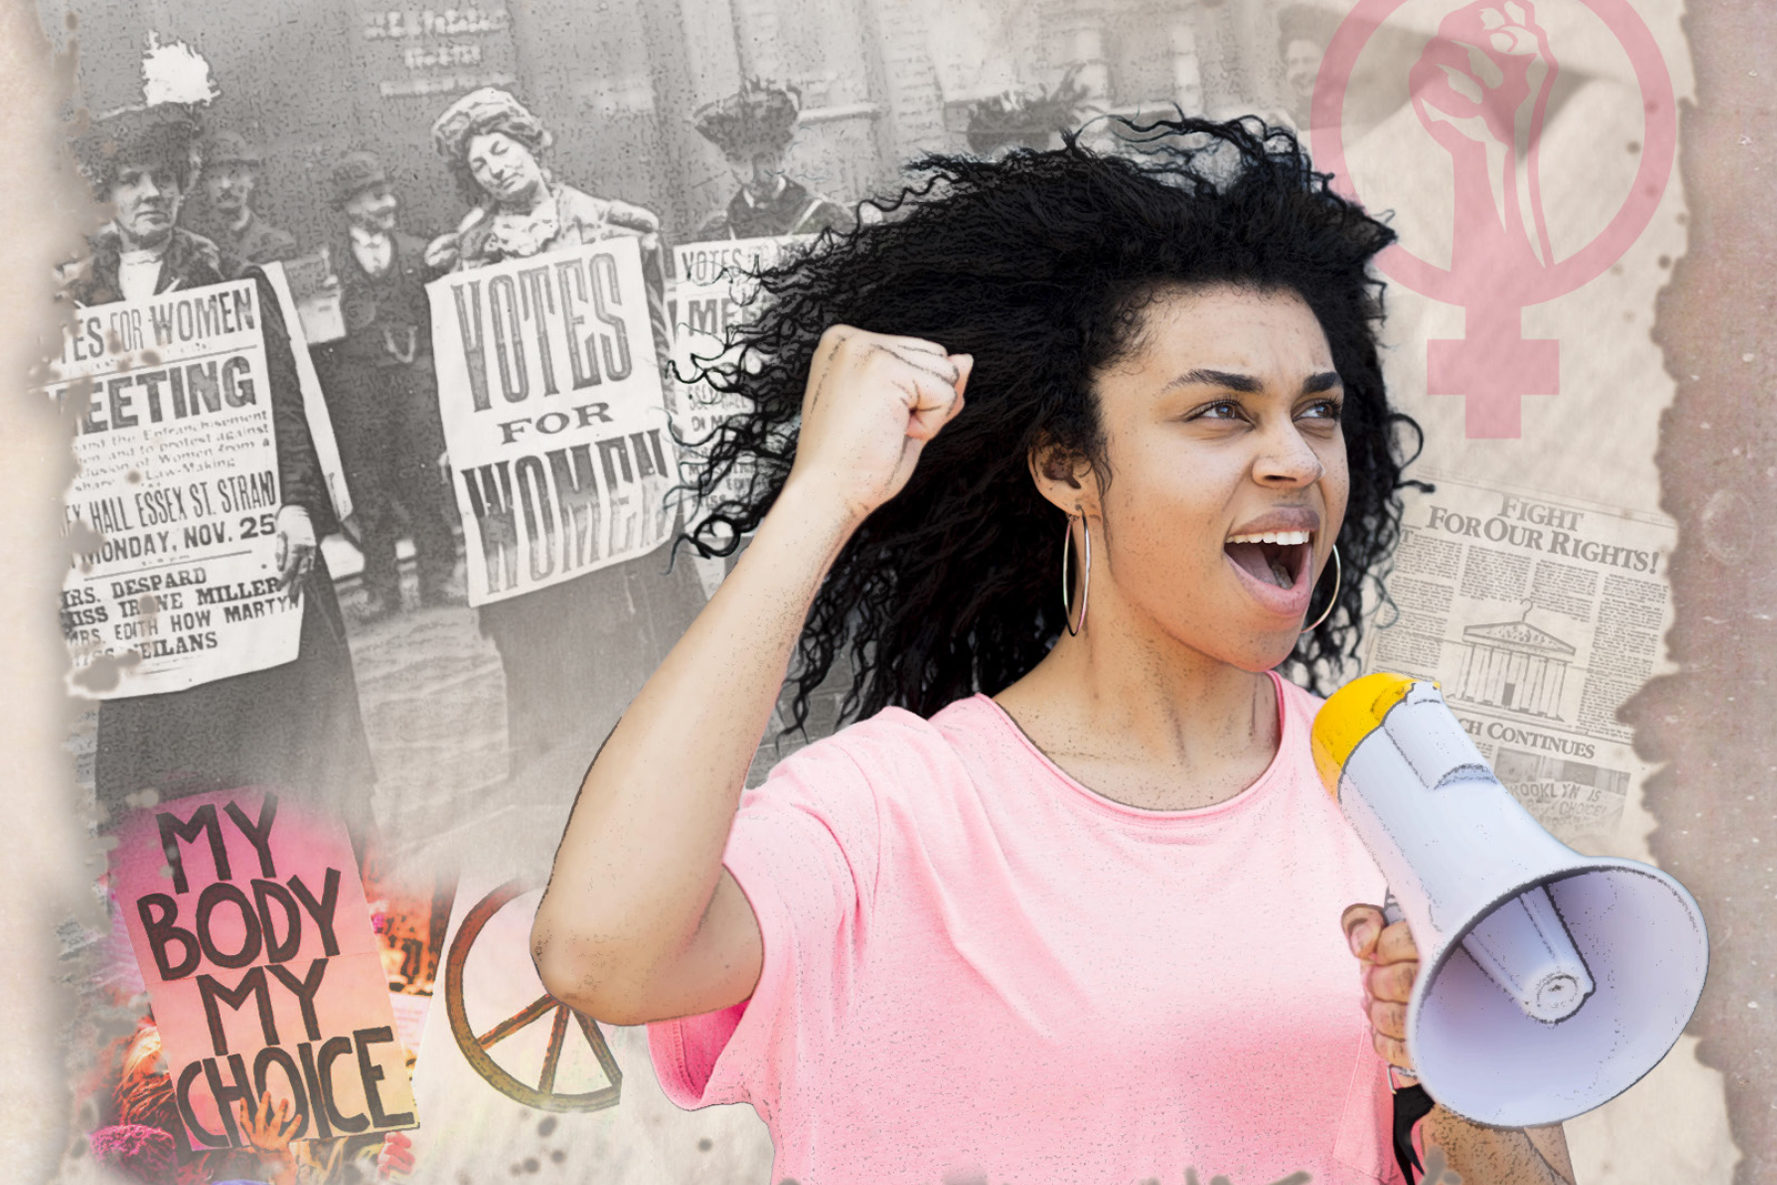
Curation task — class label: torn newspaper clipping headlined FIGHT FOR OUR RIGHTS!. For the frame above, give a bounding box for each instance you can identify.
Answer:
[1365,476,1677,851]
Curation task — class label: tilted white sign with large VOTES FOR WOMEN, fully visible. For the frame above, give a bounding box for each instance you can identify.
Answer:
[426,236,677,604]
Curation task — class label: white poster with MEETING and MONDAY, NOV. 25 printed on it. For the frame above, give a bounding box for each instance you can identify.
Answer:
[46,281,302,698]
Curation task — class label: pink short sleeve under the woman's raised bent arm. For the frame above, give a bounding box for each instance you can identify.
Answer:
[649,732,881,1119]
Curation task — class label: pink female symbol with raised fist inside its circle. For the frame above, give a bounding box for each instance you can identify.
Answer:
[1313,0,1677,439]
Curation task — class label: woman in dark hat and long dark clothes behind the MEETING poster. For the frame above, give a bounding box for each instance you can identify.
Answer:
[62,105,375,842]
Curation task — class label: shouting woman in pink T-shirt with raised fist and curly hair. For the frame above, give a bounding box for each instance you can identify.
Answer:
[533,119,1571,1185]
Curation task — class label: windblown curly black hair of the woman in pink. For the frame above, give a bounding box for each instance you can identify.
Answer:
[681,115,1422,728]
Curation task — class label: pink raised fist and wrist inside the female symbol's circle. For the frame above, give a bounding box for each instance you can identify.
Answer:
[1407,0,1557,266]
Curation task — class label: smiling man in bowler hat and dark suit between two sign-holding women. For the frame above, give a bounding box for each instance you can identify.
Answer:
[315,153,458,620]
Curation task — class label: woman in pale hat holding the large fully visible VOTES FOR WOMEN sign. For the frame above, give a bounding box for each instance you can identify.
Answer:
[428,87,704,771]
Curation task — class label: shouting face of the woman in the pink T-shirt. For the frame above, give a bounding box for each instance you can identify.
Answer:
[1088,286,1351,670]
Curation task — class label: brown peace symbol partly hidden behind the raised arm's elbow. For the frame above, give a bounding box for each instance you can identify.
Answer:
[444,879,624,1110]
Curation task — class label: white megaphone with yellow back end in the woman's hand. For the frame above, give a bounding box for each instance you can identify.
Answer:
[1313,673,1709,1128]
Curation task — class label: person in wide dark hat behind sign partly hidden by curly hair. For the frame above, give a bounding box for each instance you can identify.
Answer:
[691,78,857,240]
